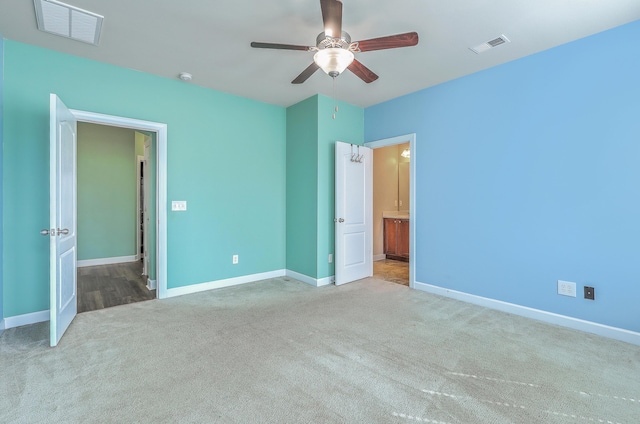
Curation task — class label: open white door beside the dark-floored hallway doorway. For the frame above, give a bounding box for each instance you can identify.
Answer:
[48,94,77,346]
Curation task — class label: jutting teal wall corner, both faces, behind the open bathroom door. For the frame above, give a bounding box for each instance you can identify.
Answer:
[287,95,364,279]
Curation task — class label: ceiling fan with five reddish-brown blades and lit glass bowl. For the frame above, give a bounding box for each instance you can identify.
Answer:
[251,0,418,84]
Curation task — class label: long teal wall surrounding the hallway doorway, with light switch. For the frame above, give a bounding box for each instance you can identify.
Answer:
[3,40,286,316]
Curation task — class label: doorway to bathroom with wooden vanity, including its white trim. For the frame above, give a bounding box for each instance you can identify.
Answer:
[365,134,416,287]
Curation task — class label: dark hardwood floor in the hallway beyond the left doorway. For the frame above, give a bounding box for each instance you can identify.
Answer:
[78,261,156,313]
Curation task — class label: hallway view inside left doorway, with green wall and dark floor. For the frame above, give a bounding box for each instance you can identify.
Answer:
[76,122,156,313]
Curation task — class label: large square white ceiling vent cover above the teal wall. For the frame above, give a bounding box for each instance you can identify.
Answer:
[34,0,104,45]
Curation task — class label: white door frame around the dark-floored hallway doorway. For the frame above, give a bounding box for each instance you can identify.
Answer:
[70,109,167,299]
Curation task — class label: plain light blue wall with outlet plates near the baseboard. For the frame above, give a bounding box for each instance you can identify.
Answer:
[365,21,640,331]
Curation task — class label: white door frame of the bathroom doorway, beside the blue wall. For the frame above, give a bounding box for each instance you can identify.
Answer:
[364,133,418,288]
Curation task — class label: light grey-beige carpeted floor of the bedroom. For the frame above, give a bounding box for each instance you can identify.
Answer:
[0,278,640,424]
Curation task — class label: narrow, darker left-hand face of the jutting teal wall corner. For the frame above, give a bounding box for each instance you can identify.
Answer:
[287,96,318,278]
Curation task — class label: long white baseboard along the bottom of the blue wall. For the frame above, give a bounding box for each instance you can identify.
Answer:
[413,281,640,345]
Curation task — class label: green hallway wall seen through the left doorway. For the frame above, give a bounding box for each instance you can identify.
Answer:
[77,122,138,261]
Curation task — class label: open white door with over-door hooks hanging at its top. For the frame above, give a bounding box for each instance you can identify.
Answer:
[335,141,373,285]
